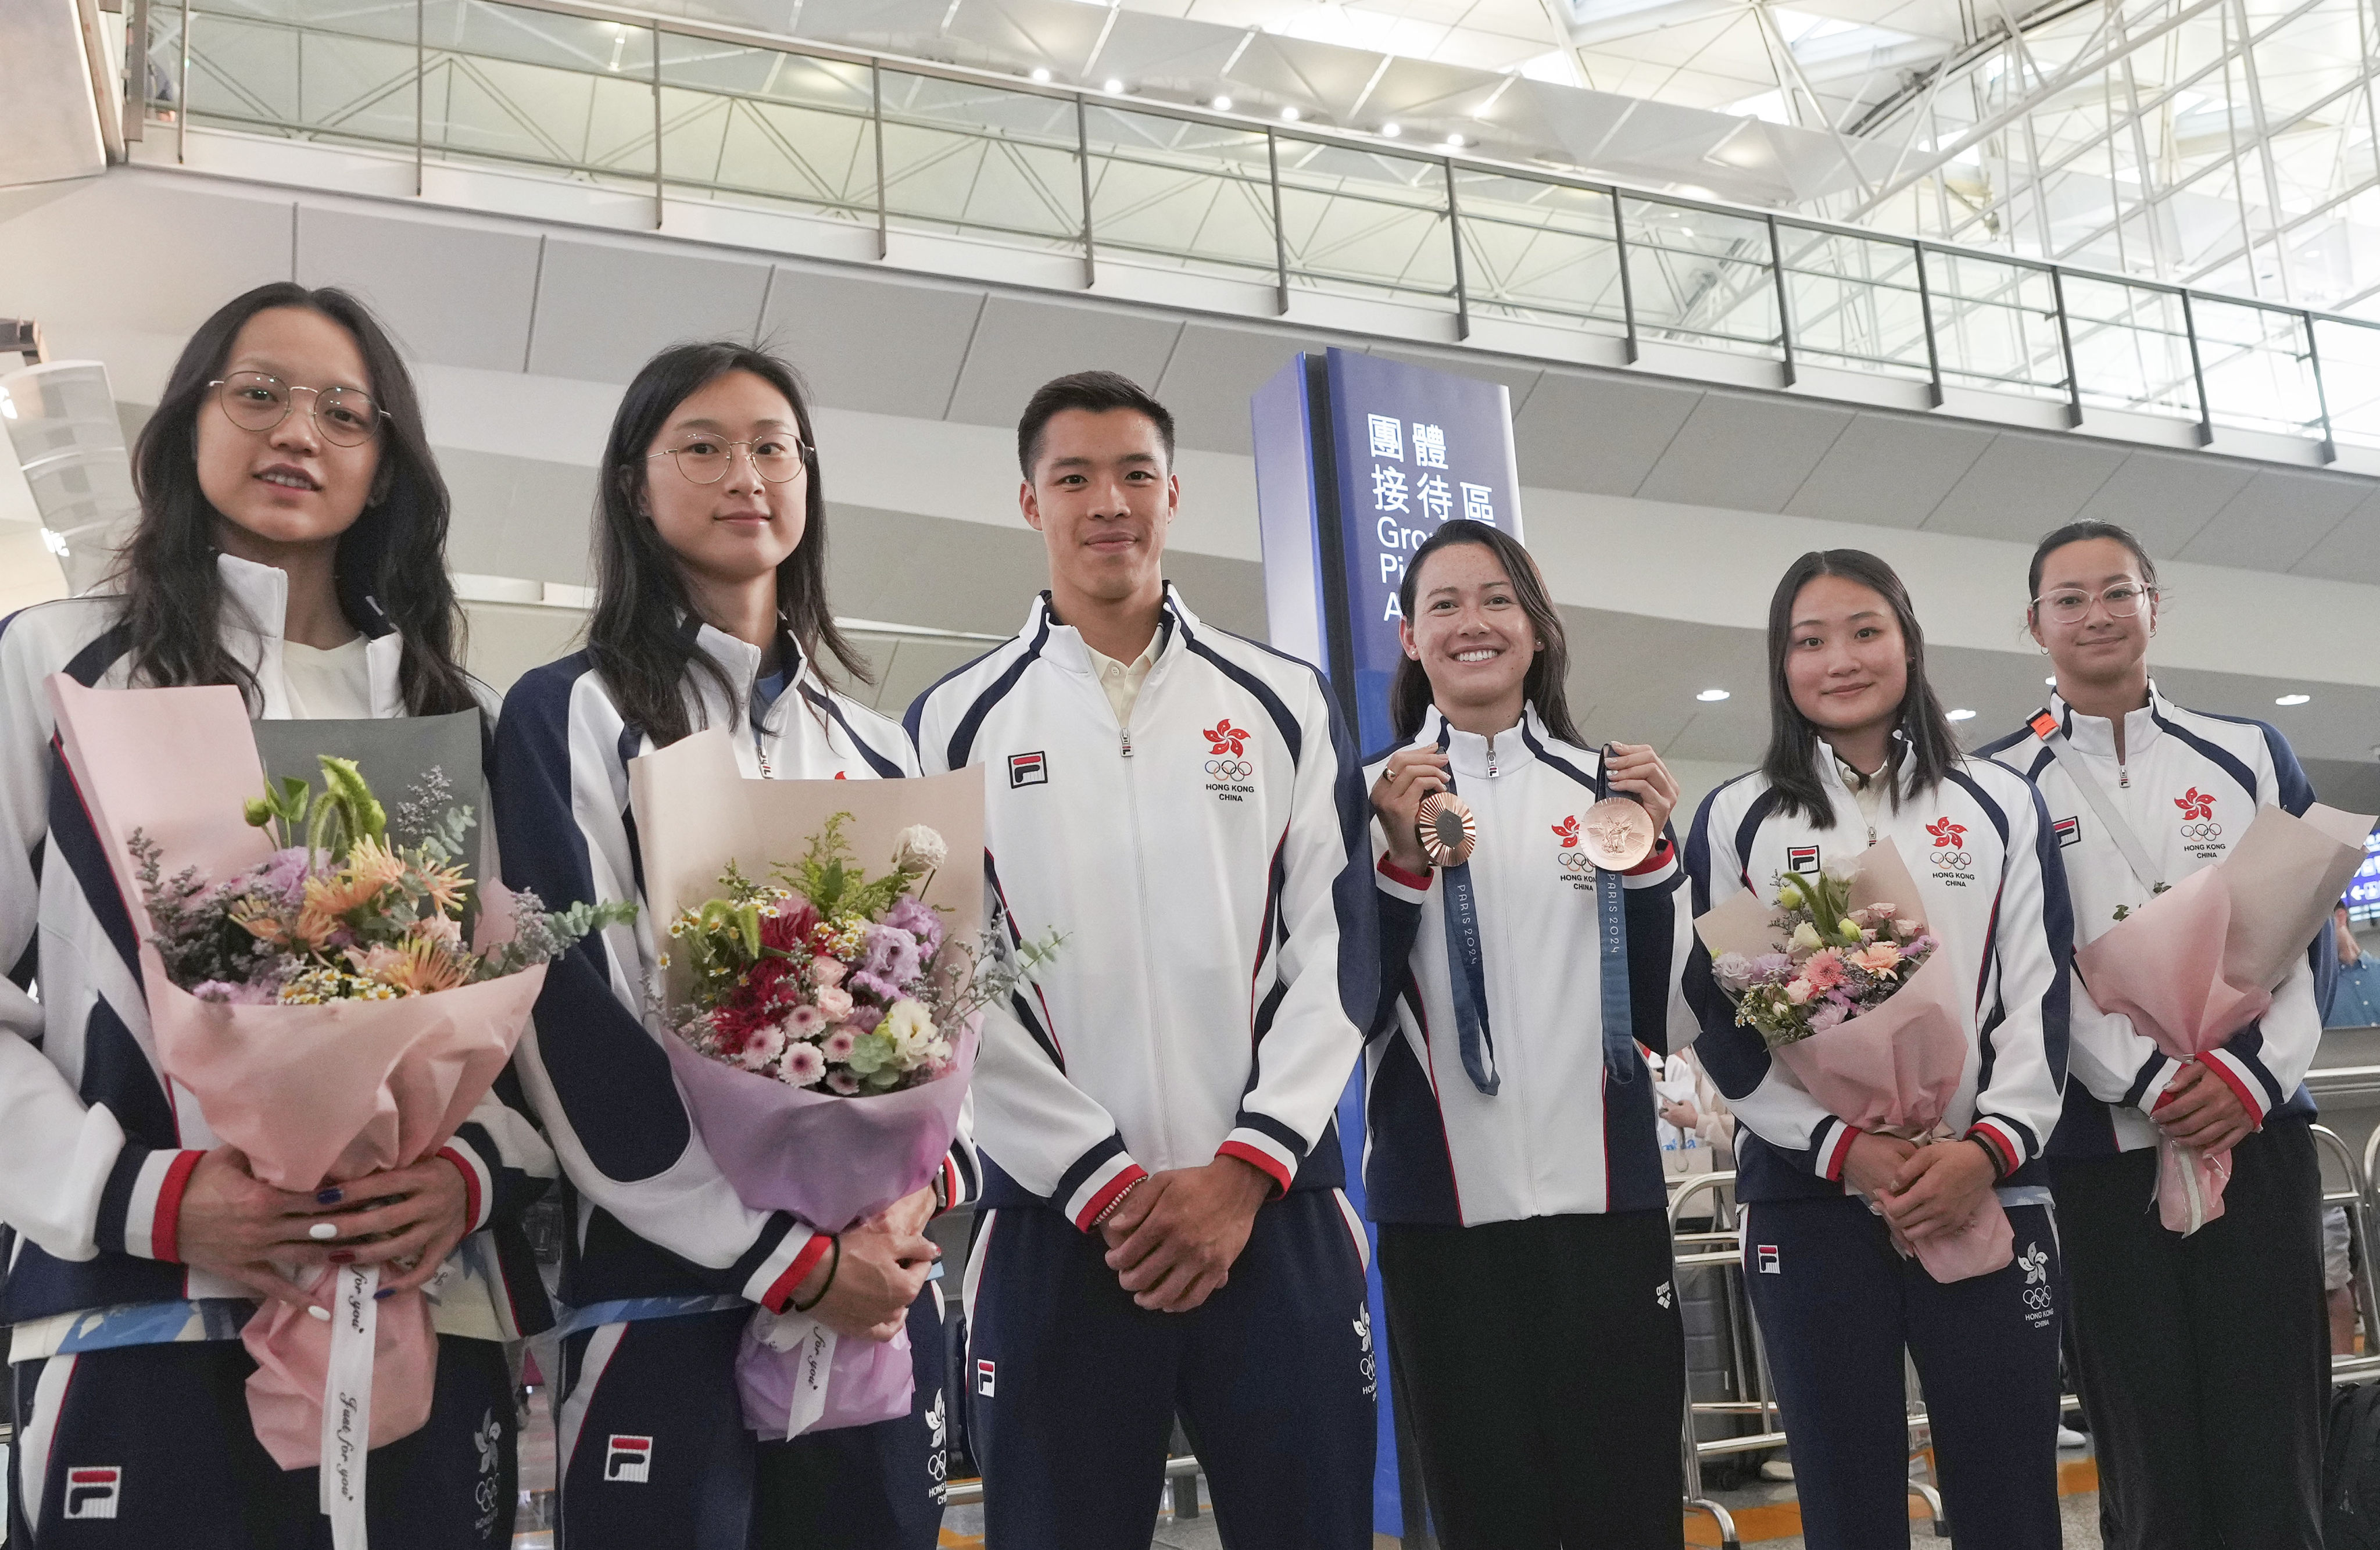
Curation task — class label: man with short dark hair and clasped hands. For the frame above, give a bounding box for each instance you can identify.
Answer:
[909,371,1380,1550]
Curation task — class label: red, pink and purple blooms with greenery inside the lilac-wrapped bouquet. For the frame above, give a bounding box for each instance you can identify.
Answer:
[661,812,1057,1098]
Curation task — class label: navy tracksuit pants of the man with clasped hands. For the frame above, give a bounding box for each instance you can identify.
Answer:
[967,1190,1378,1550]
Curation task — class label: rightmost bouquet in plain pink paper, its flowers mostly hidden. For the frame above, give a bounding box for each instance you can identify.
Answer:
[2075,804,2373,1236]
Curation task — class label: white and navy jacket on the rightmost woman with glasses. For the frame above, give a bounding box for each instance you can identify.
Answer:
[1982,683,2337,1157]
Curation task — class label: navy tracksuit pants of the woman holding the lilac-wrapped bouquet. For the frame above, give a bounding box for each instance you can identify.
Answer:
[554,1283,945,1550]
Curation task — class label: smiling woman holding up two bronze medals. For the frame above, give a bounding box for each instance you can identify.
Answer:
[1363,521,1687,1550]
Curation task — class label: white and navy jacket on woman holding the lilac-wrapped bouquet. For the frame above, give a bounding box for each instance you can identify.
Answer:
[495,619,974,1314]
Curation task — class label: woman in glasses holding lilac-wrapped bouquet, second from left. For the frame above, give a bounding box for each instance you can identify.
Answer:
[495,343,957,1550]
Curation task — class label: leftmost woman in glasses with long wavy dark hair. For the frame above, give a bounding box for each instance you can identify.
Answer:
[0,284,554,1550]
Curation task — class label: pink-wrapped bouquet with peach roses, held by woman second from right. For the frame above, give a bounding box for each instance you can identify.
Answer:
[1695,840,2013,1283]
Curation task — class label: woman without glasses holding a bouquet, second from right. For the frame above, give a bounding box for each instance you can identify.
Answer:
[1685,550,2073,1550]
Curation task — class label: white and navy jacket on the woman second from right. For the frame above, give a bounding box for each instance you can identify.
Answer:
[1685,743,2073,1202]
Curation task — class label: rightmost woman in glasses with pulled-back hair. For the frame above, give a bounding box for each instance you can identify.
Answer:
[1985,521,2337,1550]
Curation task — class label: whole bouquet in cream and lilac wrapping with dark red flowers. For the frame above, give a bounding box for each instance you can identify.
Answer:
[628,729,1009,1438]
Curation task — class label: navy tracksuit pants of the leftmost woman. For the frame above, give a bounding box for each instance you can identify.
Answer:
[7,1336,519,1550]
